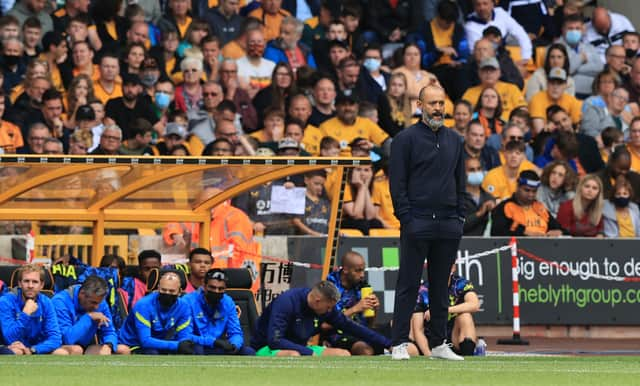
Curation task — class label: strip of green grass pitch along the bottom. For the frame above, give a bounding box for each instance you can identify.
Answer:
[0,356,640,386]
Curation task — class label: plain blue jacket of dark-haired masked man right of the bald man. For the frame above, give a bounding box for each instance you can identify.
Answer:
[183,287,244,349]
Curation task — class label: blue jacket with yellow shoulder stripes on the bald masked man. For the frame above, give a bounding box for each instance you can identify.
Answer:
[119,292,193,352]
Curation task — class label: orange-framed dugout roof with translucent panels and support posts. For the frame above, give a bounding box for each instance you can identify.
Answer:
[0,155,370,270]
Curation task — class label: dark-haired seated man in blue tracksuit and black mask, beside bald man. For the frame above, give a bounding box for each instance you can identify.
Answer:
[183,268,255,355]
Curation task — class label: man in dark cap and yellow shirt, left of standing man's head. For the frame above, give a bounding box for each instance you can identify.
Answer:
[320,94,390,156]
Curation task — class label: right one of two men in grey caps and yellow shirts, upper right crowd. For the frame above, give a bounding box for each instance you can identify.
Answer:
[529,67,582,135]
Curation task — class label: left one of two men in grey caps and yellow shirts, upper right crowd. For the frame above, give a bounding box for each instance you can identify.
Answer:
[462,57,527,122]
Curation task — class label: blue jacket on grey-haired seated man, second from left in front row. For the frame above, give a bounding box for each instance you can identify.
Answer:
[51,284,118,352]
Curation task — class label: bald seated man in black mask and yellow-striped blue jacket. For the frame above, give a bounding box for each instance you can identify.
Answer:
[118,271,196,354]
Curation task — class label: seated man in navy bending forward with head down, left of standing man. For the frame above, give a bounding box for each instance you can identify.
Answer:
[251,281,391,356]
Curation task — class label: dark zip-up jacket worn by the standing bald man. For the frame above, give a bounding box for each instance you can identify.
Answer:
[389,121,466,224]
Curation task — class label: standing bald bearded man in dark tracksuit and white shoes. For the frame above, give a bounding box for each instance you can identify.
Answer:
[389,86,466,360]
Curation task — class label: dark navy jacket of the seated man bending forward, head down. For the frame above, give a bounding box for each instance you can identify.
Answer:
[251,288,391,355]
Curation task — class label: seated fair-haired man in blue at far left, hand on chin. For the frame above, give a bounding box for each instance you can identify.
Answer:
[0,264,67,355]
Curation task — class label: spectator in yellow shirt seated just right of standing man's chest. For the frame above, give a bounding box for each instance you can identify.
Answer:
[482,141,535,200]
